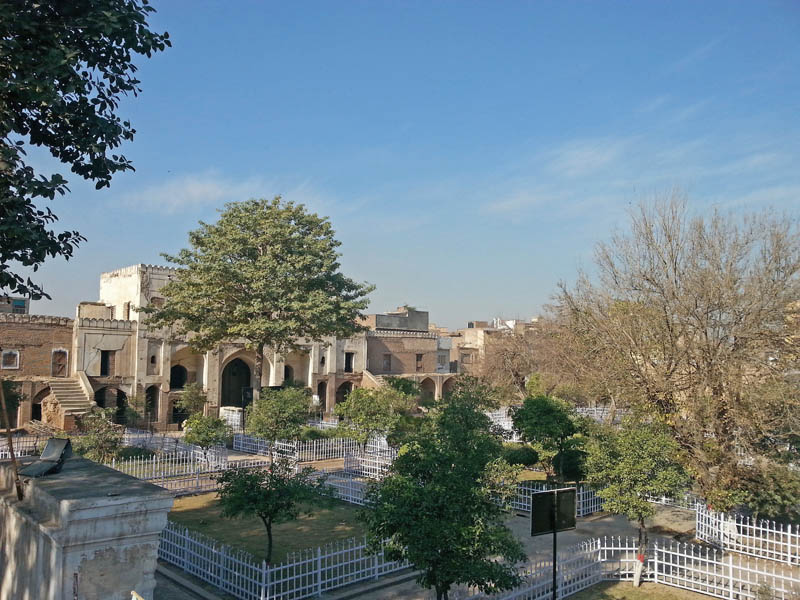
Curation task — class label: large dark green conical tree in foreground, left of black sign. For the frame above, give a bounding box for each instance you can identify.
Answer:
[361,378,525,600]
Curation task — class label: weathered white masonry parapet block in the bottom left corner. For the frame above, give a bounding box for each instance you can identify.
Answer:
[0,458,173,600]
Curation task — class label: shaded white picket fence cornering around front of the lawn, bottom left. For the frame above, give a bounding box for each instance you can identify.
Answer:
[158,522,409,600]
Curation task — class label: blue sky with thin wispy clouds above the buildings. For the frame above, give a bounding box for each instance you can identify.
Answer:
[25,0,800,327]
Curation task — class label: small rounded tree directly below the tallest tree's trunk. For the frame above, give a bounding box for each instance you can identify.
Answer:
[245,387,311,461]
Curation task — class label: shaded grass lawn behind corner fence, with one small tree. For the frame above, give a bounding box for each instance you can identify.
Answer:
[169,492,364,564]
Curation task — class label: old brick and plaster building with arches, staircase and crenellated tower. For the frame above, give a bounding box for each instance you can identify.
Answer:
[0,265,462,429]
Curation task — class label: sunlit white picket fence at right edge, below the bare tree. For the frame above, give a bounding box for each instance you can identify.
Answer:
[695,505,800,565]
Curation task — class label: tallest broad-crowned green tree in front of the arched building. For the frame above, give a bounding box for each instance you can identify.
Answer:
[145,197,373,398]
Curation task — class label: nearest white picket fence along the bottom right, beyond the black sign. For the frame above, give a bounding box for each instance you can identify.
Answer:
[457,537,800,600]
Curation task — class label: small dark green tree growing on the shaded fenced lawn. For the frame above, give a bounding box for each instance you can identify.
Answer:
[215,460,328,563]
